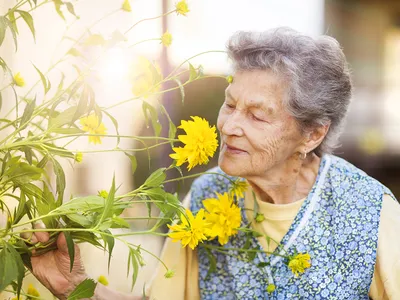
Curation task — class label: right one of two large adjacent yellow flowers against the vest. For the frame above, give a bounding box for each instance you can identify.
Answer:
[203,193,242,245]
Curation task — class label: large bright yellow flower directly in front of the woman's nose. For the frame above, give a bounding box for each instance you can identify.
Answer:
[170,117,218,171]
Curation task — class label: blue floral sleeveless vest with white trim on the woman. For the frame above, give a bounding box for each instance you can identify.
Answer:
[191,155,394,300]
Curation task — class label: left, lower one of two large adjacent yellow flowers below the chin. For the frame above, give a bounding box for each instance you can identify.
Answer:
[168,209,207,249]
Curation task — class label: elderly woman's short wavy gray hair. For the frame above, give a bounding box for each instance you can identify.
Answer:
[227,28,352,156]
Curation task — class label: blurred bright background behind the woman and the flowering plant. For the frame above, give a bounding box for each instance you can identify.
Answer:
[0,0,400,293]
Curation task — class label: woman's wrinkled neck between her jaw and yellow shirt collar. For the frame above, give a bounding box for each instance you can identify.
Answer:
[247,153,321,204]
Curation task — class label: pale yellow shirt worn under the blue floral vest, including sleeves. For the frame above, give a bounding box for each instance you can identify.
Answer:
[148,190,400,300]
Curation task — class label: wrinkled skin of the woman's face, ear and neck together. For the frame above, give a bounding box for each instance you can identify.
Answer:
[217,70,329,203]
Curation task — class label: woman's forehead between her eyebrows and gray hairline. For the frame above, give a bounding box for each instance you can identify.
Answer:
[226,70,285,108]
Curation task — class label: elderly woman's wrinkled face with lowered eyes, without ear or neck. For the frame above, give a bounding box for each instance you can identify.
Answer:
[217,70,305,178]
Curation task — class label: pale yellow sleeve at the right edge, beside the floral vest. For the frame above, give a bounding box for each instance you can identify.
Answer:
[370,194,400,300]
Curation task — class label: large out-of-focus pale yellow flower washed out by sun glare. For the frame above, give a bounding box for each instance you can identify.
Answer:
[131,56,162,98]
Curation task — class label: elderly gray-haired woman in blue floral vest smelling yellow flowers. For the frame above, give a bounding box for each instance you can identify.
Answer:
[32,28,400,300]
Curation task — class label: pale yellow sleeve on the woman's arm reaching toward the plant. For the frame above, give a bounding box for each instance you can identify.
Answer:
[147,193,200,300]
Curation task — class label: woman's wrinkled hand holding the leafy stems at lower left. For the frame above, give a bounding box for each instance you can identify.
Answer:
[23,226,88,299]
